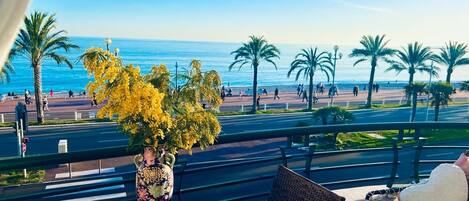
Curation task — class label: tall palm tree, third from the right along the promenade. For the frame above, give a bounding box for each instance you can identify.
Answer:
[349,35,395,107]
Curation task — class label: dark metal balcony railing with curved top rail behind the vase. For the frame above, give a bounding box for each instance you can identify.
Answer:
[0,122,469,200]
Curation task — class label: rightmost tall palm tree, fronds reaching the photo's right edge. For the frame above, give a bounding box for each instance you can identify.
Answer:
[435,41,469,83]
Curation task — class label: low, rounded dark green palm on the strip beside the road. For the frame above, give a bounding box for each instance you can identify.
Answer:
[313,106,355,147]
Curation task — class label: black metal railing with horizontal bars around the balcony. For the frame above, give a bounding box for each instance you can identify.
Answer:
[0,122,469,200]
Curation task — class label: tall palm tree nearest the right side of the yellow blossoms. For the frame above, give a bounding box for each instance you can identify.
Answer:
[229,36,280,113]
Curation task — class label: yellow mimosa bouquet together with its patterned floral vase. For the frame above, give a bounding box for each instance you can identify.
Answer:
[80,48,222,200]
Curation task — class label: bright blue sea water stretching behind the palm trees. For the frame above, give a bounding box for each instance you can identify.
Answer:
[0,37,469,93]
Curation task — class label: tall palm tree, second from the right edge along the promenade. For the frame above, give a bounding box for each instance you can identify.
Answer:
[386,42,440,105]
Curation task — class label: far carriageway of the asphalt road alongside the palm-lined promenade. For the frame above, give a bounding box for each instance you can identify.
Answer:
[0,105,469,157]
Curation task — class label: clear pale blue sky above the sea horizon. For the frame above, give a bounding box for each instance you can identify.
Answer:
[30,0,469,46]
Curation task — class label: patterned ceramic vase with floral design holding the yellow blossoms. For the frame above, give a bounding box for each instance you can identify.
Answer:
[134,147,175,201]
